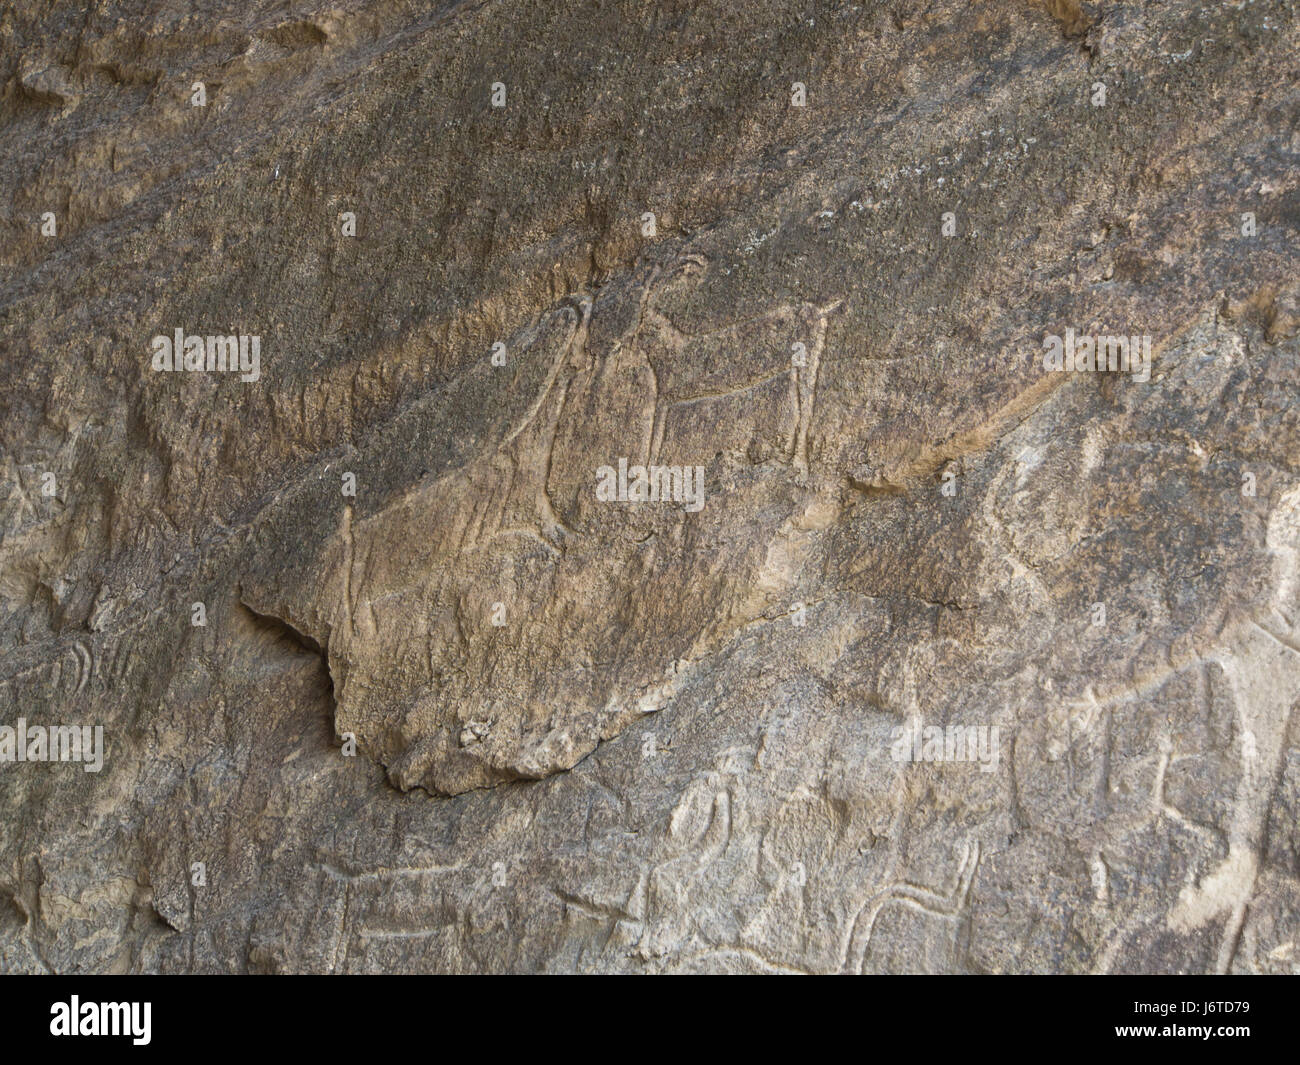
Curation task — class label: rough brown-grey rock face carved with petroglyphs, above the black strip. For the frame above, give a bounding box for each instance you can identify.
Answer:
[0,0,1300,973]
